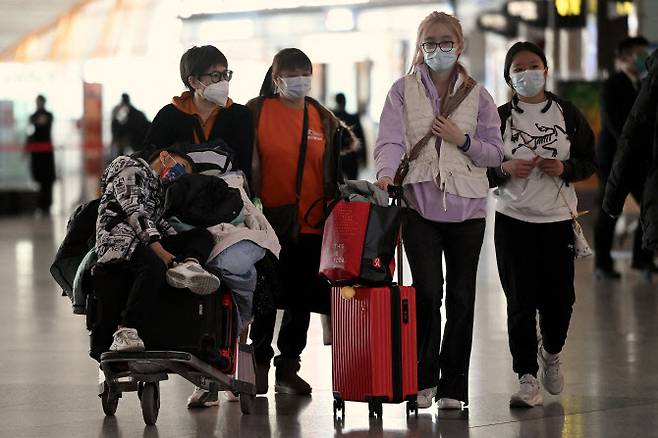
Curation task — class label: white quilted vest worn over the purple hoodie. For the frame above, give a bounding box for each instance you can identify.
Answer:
[403,72,489,198]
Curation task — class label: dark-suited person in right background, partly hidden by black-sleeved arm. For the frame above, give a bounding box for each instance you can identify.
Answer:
[594,36,658,280]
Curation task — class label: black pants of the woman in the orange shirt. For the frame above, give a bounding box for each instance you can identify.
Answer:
[250,234,331,364]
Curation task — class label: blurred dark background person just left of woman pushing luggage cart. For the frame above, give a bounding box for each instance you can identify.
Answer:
[111,93,150,159]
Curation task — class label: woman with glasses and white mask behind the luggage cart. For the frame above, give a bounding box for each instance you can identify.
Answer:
[144,46,254,186]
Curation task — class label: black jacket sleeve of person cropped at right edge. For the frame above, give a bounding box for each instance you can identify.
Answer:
[603,68,658,216]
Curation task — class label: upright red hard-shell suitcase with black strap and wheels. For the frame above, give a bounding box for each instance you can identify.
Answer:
[331,186,418,417]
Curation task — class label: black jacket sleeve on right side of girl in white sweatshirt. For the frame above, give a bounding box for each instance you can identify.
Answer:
[559,101,596,183]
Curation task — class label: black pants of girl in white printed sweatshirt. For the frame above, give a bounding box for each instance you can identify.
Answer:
[494,213,576,377]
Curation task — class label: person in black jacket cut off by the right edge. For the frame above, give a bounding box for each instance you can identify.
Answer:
[603,50,658,279]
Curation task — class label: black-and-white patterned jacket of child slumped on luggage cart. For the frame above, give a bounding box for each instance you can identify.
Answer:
[96,156,176,263]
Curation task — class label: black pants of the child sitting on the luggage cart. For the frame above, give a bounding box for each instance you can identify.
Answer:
[94,228,214,329]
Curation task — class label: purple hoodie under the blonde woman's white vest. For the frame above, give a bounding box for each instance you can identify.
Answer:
[374,64,503,222]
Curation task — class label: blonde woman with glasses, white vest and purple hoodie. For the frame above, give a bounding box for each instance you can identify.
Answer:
[374,12,503,409]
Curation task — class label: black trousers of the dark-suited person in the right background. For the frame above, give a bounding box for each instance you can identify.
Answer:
[594,177,653,270]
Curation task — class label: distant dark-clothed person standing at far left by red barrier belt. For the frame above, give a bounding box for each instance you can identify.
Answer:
[25,95,55,216]
